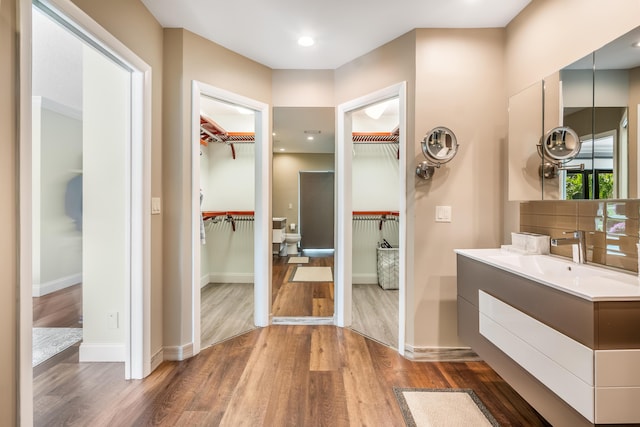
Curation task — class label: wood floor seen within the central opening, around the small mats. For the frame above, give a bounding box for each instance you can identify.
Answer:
[271,254,334,317]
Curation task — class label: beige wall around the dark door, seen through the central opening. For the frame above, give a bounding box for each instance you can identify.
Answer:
[272,153,334,227]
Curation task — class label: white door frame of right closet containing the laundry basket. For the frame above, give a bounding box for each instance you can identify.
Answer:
[335,82,407,355]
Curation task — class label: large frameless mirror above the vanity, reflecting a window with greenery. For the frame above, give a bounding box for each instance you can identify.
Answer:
[509,27,640,200]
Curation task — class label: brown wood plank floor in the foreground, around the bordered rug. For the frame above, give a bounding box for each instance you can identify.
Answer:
[34,326,548,426]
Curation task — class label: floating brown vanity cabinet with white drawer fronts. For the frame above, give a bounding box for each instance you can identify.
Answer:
[457,253,640,426]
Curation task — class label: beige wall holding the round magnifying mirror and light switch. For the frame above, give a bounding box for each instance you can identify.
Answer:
[407,29,507,347]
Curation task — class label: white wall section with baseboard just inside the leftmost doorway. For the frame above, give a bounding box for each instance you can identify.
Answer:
[80,47,131,361]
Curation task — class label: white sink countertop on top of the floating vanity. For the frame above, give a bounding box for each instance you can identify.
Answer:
[454,249,640,301]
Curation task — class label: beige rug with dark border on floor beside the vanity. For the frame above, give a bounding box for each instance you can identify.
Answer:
[393,387,500,427]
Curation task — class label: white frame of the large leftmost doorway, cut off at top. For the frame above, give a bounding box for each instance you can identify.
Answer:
[18,0,151,425]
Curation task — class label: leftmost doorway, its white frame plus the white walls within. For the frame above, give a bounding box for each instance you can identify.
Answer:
[19,0,151,424]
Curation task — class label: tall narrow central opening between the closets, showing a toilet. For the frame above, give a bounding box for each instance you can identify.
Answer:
[272,107,335,324]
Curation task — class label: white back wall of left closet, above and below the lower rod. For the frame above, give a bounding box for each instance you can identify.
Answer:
[200,142,255,285]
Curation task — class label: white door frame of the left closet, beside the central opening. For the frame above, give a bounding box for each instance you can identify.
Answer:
[191,80,272,354]
